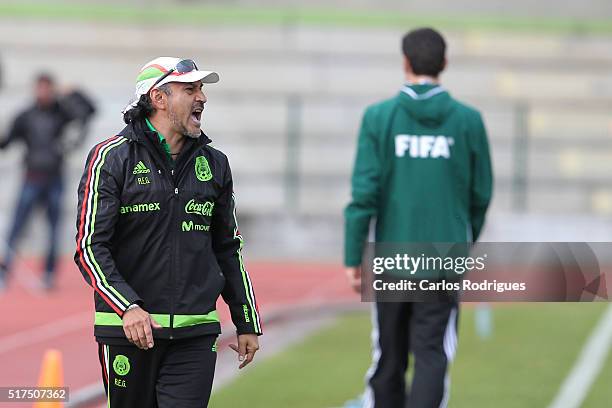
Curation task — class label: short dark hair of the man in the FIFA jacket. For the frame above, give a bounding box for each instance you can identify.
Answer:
[402,28,446,77]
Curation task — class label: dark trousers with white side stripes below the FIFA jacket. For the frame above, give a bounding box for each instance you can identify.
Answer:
[364,301,458,408]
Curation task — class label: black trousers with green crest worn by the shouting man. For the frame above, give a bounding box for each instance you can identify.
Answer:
[98,335,217,408]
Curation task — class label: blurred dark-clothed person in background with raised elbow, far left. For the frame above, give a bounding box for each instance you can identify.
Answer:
[0,73,95,289]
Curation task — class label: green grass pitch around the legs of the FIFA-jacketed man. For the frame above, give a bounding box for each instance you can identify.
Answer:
[210,303,612,408]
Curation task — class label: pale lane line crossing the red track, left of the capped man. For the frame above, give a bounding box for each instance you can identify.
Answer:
[0,312,93,354]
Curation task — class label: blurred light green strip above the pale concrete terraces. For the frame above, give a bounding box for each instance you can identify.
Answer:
[0,0,612,34]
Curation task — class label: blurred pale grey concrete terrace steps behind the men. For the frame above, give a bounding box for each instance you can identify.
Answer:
[0,20,612,256]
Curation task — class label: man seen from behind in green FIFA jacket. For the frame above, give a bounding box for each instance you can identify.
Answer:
[344,28,493,408]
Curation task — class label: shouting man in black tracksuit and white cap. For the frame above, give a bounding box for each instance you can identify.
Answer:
[75,57,262,408]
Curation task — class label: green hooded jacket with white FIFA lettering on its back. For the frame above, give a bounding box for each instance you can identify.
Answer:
[344,85,493,266]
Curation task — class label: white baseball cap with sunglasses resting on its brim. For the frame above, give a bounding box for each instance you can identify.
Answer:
[123,57,219,113]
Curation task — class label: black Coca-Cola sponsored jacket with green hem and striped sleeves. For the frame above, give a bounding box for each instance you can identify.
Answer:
[75,118,261,343]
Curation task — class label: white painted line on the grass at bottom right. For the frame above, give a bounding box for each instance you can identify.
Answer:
[549,305,612,408]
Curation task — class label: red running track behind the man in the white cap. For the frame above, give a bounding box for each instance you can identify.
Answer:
[0,257,359,408]
